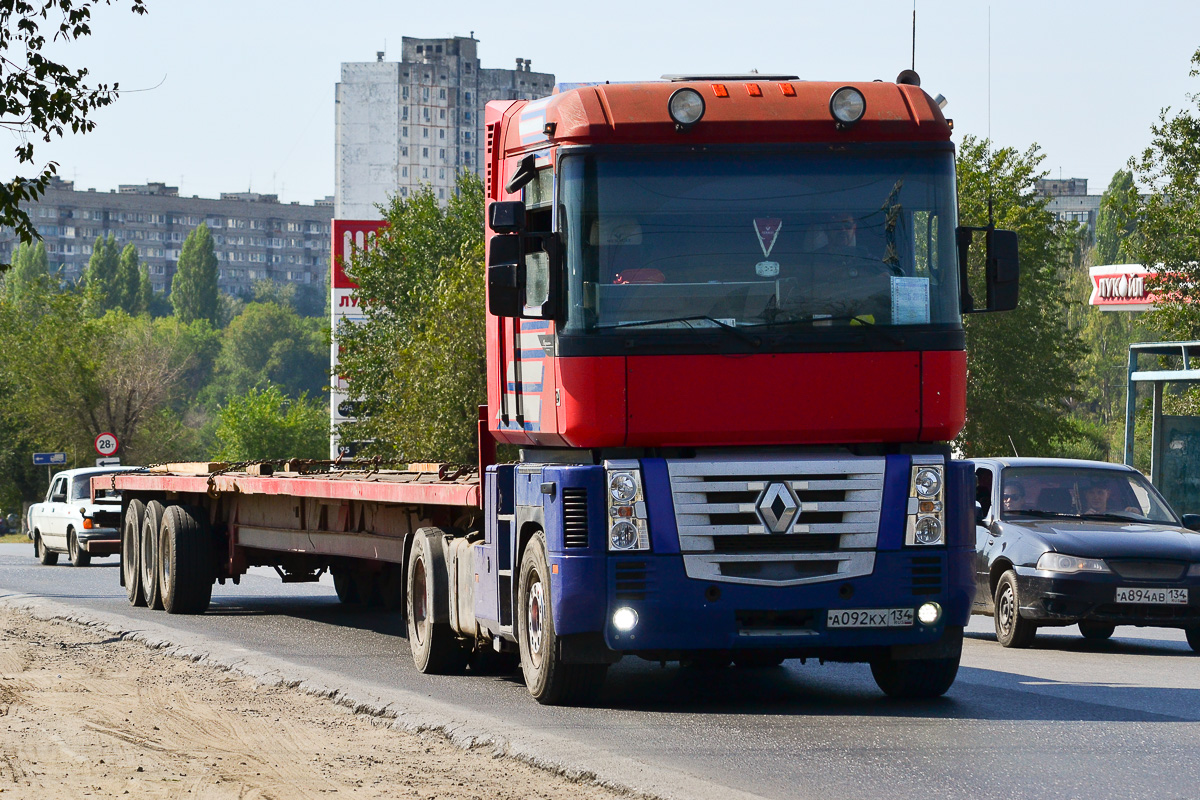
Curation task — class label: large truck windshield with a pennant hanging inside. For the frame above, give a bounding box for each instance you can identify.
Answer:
[559,148,961,332]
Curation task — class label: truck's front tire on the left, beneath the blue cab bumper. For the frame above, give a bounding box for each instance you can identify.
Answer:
[517,533,608,705]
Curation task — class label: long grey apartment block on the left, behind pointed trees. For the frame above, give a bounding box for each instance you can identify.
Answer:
[0,179,334,294]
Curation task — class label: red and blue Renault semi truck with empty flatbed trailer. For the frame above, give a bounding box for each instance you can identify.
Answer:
[108,74,1018,704]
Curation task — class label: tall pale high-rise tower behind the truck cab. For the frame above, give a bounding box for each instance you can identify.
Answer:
[334,35,554,219]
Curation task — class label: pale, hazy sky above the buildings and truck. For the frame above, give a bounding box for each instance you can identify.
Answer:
[23,0,1200,203]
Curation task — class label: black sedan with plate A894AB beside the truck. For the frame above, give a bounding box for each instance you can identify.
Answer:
[973,458,1200,652]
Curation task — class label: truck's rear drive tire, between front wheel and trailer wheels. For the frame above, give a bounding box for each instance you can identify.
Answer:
[404,528,467,675]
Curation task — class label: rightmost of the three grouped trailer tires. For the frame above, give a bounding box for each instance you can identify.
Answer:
[158,506,214,614]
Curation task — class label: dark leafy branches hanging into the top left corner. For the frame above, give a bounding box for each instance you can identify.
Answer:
[0,0,145,256]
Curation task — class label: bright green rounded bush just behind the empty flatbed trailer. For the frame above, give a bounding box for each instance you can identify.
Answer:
[212,386,329,461]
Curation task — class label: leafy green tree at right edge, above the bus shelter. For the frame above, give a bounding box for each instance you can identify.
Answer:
[1129,49,1200,339]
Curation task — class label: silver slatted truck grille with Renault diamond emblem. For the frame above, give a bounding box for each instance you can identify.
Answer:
[667,456,884,587]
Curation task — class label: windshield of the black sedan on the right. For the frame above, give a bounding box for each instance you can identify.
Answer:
[1001,465,1180,525]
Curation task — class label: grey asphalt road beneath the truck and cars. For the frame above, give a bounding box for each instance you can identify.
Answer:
[0,545,1200,800]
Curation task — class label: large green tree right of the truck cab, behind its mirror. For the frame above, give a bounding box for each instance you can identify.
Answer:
[958,136,1081,456]
